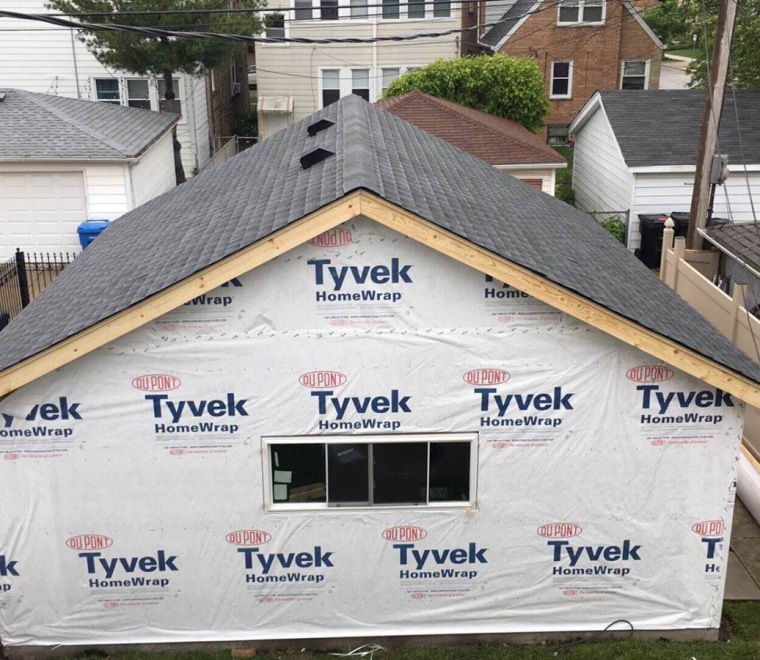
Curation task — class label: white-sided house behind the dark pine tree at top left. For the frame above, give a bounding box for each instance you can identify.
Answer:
[0,0,211,177]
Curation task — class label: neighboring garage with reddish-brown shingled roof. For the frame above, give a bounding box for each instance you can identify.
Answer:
[377,91,567,195]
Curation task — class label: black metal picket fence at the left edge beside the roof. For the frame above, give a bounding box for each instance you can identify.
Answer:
[0,248,76,330]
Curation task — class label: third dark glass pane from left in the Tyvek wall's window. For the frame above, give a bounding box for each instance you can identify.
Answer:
[373,442,428,504]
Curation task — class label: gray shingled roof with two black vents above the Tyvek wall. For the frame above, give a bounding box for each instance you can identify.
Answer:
[0,96,760,382]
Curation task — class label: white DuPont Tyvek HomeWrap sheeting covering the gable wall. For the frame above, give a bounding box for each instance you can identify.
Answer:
[0,219,741,646]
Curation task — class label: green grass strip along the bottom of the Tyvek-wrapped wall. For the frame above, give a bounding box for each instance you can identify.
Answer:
[98,603,760,660]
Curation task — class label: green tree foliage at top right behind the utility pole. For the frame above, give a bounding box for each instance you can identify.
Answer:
[687,0,760,88]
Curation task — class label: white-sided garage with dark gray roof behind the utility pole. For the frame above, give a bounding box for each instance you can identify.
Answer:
[570,89,760,249]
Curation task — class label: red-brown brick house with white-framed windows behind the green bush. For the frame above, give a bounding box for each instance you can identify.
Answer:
[480,0,662,144]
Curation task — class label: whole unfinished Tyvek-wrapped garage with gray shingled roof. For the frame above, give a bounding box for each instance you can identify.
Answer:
[0,96,760,656]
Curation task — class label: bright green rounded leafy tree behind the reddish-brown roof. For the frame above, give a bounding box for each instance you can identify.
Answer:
[384,55,549,132]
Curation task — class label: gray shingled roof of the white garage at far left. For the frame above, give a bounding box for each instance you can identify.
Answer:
[0,89,179,161]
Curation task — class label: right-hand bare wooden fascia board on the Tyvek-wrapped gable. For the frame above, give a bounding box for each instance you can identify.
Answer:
[361,193,760,407]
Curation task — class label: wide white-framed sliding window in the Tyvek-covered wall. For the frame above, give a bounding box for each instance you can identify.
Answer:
[265,434,477,508]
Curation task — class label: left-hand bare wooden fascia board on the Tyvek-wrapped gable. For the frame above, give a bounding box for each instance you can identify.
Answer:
[0,193,360,397]
